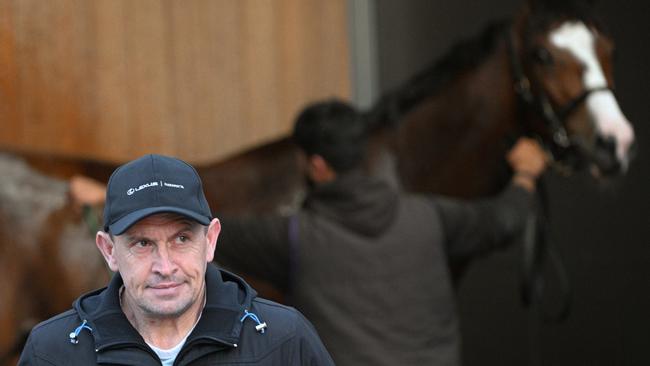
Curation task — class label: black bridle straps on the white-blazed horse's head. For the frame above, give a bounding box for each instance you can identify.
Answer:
[506,26,613,172]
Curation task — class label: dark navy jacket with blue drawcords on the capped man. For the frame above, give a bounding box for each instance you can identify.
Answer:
[19,266,334,366]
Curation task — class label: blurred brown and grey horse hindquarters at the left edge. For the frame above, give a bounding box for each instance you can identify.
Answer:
[0,153,110,365]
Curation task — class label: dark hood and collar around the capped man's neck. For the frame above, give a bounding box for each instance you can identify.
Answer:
[70,264,257,352]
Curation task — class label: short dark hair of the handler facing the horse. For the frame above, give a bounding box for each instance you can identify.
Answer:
[292,99,367,172]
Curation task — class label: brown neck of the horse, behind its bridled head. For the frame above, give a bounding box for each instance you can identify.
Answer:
[390,42,520,197]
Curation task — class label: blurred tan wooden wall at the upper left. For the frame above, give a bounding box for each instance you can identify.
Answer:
[0,0,350,163]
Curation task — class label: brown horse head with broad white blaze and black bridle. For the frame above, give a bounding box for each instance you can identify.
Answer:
[510,0,634,176]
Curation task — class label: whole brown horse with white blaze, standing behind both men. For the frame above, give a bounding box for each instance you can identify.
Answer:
[0,0,634,364]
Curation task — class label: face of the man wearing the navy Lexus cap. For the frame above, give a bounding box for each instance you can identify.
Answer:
[100,214,219,318]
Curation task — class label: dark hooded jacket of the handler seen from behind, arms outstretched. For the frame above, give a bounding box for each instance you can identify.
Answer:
[215,173,532,366]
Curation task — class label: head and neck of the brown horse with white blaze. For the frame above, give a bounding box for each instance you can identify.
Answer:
[368,1,634,198]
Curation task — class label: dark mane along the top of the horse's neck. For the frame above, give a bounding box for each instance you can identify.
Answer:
[366,21,510,131]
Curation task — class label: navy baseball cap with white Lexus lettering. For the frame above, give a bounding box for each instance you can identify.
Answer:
[104,154,212,235]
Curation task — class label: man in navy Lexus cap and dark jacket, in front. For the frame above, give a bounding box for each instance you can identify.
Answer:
[19,155,333,366]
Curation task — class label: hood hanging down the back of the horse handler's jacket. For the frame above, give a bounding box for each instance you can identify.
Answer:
[305,171,398,237]
